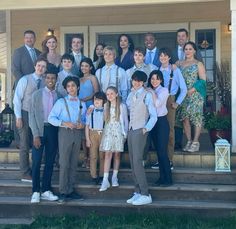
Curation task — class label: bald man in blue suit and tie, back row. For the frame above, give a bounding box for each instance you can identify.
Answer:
[144,33,161,67]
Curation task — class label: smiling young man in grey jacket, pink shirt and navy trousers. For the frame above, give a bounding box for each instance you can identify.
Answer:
[29,68,58,203]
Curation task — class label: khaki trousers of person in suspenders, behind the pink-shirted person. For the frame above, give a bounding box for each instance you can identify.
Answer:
[167,95,176,161]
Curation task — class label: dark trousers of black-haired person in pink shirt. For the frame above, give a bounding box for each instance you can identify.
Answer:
[151,116,172,184]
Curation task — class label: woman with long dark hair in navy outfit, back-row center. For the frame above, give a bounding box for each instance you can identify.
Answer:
[115,34,134,70]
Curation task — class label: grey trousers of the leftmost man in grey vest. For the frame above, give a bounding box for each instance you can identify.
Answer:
[18,110,32,176]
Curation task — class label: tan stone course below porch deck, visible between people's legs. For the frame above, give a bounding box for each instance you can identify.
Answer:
[0,148,236,168]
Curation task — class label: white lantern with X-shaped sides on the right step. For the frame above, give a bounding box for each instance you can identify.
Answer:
[215,139,231,172]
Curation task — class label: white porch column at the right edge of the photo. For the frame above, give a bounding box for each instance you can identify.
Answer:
[230,0,236,152]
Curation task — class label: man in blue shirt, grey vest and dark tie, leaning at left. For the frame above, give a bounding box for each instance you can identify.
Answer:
[13,58,47,182]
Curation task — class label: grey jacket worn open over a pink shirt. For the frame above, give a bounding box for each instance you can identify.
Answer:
[29,88,58,137]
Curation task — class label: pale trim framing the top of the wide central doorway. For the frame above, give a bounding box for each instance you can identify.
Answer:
[89,23,189,56]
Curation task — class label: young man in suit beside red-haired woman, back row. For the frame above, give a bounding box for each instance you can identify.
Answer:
[71,35,86,76]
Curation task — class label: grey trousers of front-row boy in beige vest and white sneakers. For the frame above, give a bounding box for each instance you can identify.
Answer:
[128,129,149,195]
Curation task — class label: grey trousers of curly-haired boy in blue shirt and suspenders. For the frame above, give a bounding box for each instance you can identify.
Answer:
[58,127,83,195]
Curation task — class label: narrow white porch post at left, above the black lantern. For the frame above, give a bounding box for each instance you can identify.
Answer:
[5,10,13,104]
